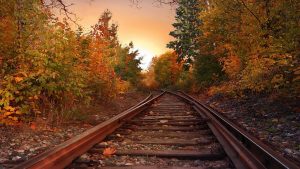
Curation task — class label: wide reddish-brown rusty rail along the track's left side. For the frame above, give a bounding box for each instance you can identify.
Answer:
[15,92,165,169]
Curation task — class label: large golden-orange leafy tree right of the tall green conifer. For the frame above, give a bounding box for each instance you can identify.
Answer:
[206,0,299,92]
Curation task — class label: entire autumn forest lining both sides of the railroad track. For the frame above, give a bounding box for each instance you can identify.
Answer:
[0,0,300,124]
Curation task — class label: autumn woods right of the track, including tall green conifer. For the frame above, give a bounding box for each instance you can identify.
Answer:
[147,0,300,96]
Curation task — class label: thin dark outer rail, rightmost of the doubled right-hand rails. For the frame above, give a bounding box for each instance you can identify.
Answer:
[173,91,300,169]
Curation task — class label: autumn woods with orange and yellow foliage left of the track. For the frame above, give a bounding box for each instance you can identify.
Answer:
[0,0,141,124]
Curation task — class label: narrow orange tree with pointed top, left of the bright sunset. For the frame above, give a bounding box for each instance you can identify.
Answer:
[90,10,119,98]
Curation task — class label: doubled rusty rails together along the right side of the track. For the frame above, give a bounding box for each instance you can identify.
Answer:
[170,91,300,169]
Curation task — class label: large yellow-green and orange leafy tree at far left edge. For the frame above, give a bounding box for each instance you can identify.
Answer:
[0,0,94,124]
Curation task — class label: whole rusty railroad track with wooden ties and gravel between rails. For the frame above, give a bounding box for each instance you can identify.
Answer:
[11,92,299,169]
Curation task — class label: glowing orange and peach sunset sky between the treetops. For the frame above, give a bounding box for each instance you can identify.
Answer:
[65,0,175,69]
